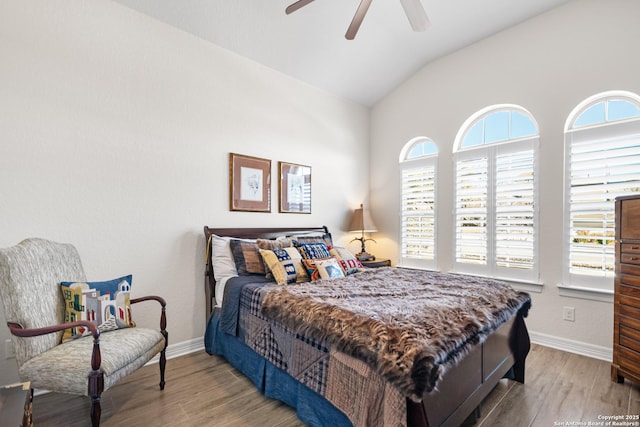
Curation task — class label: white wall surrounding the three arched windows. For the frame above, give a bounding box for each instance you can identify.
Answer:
[371,0,640,350]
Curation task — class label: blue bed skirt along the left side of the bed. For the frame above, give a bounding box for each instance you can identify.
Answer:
[204,312,352,427]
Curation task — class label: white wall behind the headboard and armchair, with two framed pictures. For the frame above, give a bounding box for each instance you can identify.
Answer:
[0,0,369,384]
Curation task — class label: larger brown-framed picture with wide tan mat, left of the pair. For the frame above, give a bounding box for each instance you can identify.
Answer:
[229,153,271,212]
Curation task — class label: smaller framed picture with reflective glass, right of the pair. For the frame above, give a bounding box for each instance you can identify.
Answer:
[278,162,311,213]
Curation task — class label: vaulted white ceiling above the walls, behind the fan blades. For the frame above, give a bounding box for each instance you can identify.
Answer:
[115,0,577,106]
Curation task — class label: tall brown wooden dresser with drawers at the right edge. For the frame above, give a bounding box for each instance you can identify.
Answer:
[611,195,640,384]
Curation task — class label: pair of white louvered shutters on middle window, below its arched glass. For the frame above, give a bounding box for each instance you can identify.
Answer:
[455,138,538,281]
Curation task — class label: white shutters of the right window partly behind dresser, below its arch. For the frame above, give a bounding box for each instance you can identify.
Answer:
[566,121,640,289]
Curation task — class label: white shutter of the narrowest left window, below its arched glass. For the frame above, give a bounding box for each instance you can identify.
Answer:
[400,158,436,267]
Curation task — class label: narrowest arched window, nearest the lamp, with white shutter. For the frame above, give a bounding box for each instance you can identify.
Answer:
[400,137,438,269]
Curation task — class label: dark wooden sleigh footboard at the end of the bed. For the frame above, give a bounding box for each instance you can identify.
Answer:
[407,307,530,427]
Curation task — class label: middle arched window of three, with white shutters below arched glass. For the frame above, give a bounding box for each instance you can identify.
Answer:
[454,105,539,281]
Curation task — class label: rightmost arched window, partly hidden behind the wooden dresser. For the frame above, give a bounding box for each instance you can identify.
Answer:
[563,91,640,292]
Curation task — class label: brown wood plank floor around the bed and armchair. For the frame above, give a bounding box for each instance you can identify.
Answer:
[33,345,640,427]
